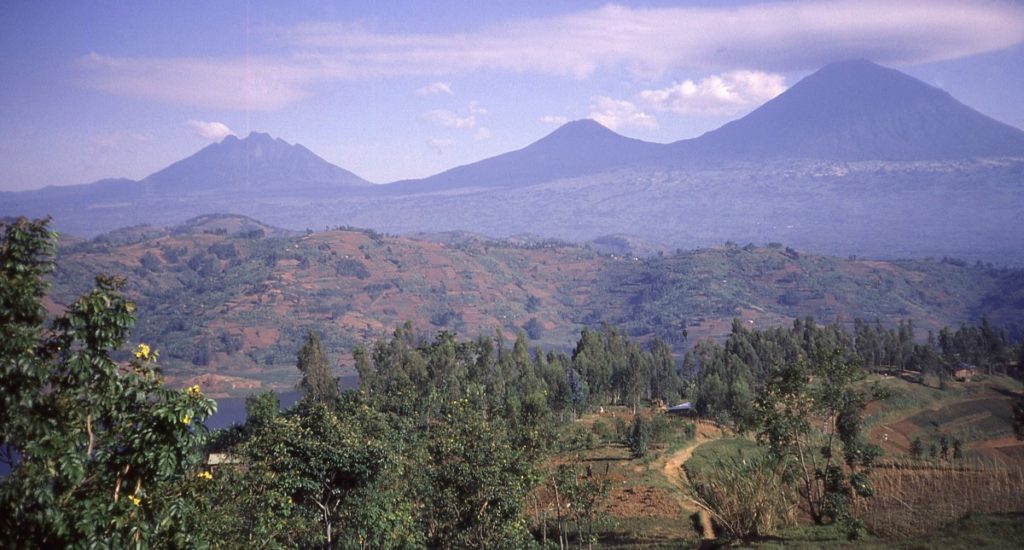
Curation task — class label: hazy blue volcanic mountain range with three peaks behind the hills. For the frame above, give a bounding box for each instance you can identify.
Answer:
[0,60,1024,263]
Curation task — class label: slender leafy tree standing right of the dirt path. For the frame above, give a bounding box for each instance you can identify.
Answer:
[754,349,881,533]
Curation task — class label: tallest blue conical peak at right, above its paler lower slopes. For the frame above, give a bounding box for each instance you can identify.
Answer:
[672,60,1024,161]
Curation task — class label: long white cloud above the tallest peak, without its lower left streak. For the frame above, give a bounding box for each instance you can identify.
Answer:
[282,0,1024,77]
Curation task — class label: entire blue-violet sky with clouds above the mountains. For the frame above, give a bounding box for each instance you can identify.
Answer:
[0,0,1024,191]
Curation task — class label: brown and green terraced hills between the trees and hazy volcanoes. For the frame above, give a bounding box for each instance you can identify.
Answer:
[50,216,1024,393]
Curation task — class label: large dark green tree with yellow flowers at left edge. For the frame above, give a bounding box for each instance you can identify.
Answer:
[0,218,216,547]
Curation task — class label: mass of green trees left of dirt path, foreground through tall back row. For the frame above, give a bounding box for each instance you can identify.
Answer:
[189,323,682,548]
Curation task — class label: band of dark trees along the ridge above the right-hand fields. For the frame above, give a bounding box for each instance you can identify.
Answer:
[681,316,1024,422]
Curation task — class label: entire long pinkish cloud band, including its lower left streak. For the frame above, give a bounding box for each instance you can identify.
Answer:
[80,0,1024,111]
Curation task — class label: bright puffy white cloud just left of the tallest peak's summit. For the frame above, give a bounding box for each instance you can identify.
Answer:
[639,71,786,116]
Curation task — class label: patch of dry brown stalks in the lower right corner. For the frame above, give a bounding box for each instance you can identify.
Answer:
[855,460,1024,538]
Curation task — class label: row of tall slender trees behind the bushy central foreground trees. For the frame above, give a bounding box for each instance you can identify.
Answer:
[354,323,683,419]
